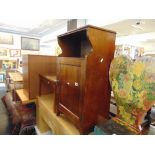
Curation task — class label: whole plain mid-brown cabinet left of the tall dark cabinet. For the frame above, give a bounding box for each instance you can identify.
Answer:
[22,55,56,100]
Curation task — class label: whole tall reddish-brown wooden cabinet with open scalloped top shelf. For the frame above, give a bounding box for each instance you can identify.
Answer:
[57,25,116,134]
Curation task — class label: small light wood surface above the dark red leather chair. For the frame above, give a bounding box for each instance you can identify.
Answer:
[16,89,36,104]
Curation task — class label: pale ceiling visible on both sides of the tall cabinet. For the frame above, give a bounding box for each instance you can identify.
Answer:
[0,18,155,41]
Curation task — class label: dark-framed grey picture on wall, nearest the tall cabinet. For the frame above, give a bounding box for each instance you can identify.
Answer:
[21,37,40,51]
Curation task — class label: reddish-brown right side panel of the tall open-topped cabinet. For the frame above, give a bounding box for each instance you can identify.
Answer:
[84,29,115,122]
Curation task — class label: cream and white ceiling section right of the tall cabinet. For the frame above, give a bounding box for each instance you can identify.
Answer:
[103,19,155,46]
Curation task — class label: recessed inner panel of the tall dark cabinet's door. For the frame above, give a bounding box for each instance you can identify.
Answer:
[59,64,81,116]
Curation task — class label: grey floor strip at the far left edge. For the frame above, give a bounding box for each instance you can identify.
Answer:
[0,83,11,135]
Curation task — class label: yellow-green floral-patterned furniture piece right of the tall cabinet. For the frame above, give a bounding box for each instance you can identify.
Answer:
[94,56,155,135]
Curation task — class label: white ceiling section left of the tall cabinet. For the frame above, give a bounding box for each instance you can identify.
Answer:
[0,19,67,37]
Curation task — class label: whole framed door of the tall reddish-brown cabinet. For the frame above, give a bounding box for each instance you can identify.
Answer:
[58,59,83,121]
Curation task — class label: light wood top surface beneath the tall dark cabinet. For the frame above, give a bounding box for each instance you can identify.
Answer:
[37,94,80,135]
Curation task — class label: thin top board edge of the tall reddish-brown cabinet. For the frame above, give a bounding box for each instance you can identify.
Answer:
[58,25,116,38]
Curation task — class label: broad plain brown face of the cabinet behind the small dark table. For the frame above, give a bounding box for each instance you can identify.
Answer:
[29,55,56,99]
